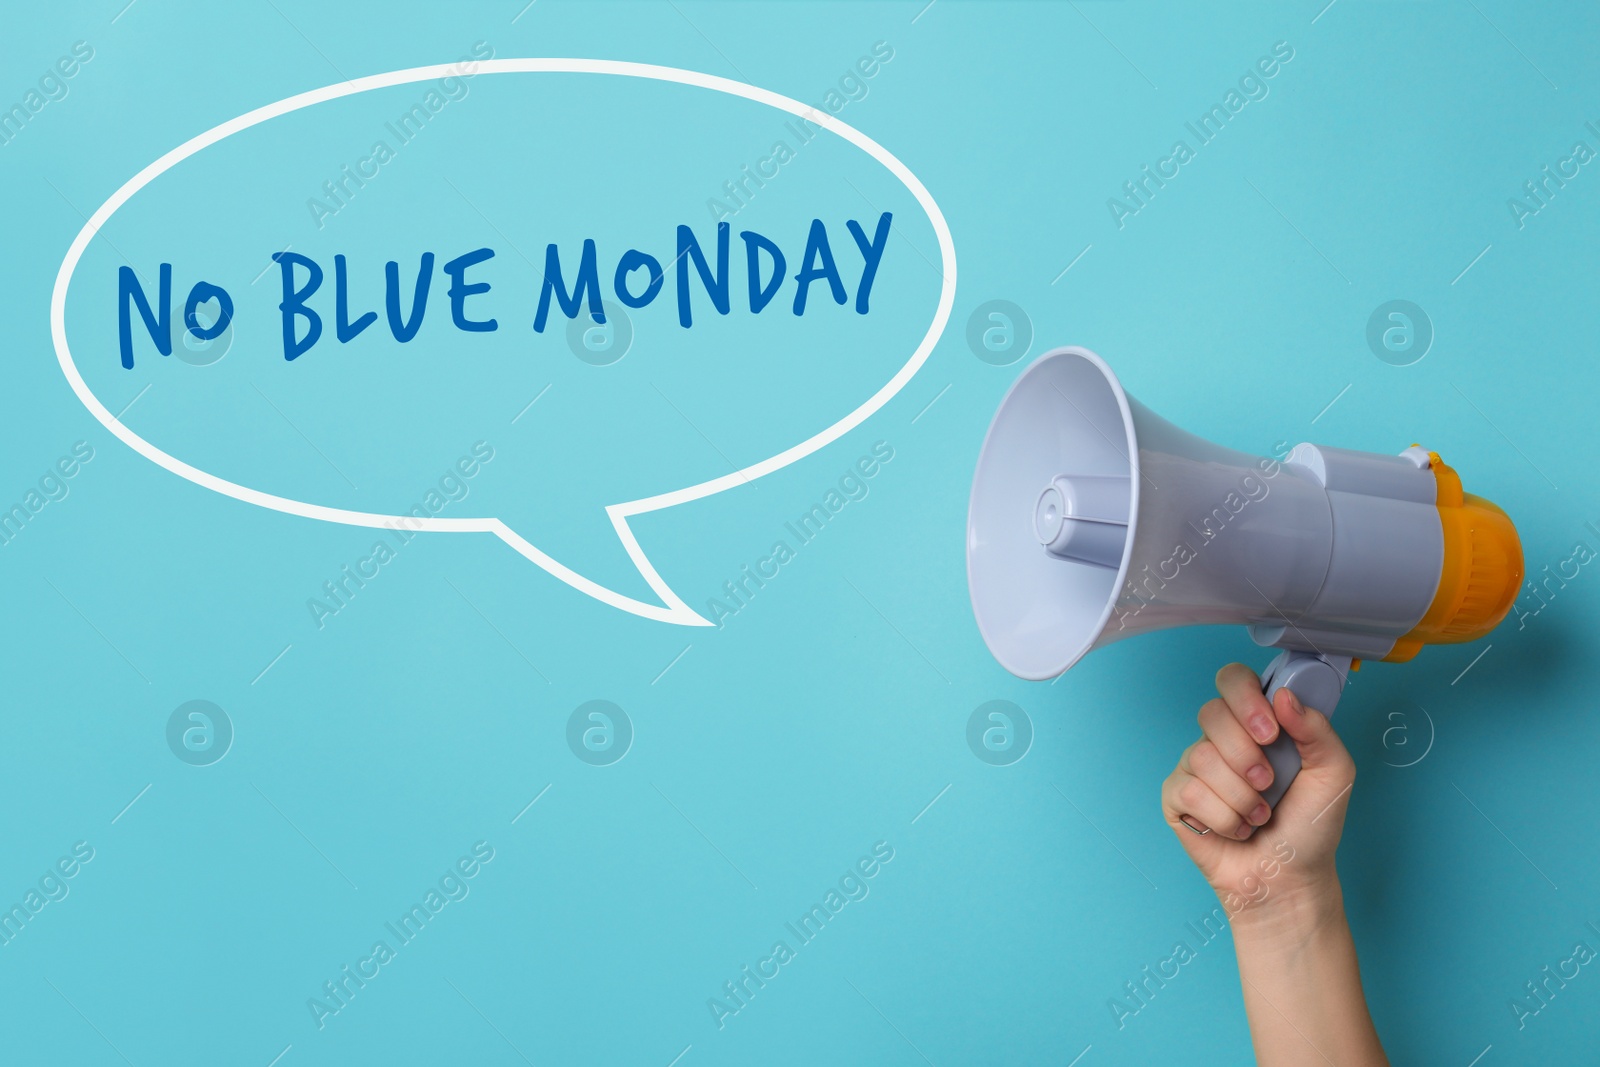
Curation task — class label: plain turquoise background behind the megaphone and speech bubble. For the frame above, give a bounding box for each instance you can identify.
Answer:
[0,0,1600,1067]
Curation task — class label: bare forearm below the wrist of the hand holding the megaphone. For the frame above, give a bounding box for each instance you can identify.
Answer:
[1234,878,1389,1067]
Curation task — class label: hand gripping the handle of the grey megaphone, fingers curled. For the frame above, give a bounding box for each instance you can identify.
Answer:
[1162,664,1355,915]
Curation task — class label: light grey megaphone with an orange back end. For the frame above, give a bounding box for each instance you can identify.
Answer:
[966,347,1523,806]
